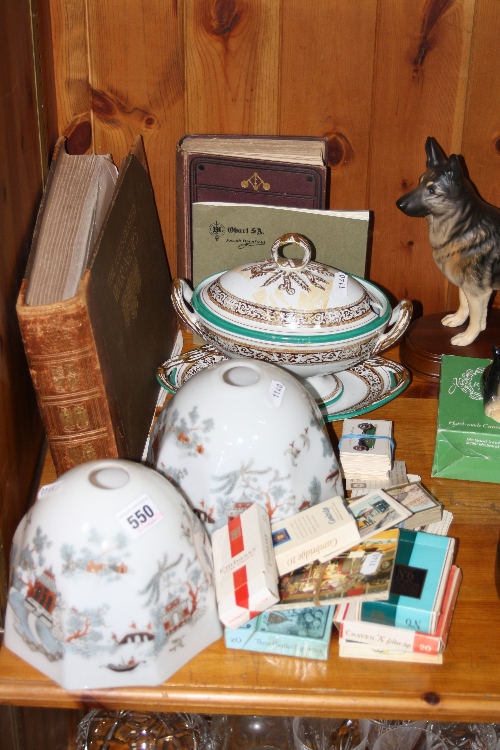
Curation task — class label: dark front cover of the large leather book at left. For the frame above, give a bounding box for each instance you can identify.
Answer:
[90,139,175,460]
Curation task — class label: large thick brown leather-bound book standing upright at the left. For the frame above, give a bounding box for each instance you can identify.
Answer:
[16,137,175,474]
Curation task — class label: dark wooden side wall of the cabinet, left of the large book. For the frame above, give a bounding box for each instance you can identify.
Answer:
[0,0,44,622]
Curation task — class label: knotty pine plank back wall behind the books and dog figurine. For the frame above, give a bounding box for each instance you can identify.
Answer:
[46,0,500,313]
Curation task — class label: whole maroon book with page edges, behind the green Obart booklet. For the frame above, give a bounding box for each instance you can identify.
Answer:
[176,135,327,281]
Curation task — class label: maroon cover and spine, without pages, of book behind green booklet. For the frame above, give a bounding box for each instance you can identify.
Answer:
[176,135,327,280]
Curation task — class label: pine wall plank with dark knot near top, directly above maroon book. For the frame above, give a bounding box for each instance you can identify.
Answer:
[184,0,281,135]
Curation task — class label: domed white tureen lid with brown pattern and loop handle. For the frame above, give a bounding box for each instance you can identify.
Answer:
[192,233,390,338]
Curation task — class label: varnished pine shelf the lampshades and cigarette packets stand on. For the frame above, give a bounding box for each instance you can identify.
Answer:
[0,368,500,722]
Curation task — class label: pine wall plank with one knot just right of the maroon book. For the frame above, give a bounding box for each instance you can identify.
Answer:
[279,0,377,210]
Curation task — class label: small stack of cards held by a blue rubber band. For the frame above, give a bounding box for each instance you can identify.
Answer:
[339,418,394,480]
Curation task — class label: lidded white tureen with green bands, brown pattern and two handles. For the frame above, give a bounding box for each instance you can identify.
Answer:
[172,234,412,406]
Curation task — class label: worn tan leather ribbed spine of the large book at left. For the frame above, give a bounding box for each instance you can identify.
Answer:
[16,271,124,474]
